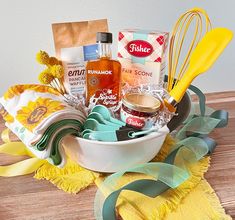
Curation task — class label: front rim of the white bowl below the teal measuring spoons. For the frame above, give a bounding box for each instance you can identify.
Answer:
[76,126,170,146]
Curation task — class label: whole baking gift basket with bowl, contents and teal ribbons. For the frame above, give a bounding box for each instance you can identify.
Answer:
[0,8,233,220]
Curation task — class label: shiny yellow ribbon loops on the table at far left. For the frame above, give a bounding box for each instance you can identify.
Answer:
[0,129,48,177]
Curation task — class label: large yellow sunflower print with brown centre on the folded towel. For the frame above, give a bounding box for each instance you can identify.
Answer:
[16,97,65,132]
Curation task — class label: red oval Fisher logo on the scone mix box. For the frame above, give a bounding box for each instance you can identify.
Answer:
[126,40,153,57]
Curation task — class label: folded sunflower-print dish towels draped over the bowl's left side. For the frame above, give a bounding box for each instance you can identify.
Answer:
[0,85,86,167]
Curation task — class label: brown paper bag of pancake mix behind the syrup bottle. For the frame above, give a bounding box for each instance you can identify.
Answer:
[52,19,108,98]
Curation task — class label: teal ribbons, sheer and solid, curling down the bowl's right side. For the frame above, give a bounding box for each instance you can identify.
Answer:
[94,86,228,220]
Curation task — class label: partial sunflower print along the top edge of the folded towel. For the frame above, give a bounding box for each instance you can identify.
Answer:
[4,84,60,100]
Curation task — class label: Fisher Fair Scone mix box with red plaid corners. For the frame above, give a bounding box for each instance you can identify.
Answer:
[118,29,169,88]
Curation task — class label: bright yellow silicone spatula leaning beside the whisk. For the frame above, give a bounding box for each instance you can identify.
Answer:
[167,28,233,107]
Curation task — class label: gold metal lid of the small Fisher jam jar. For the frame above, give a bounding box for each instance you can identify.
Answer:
[122,93,161,113]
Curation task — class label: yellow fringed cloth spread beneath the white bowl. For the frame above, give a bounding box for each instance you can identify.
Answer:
[35,136,231,220]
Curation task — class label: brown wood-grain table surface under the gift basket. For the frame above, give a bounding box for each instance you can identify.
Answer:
[0,91,235,220]
